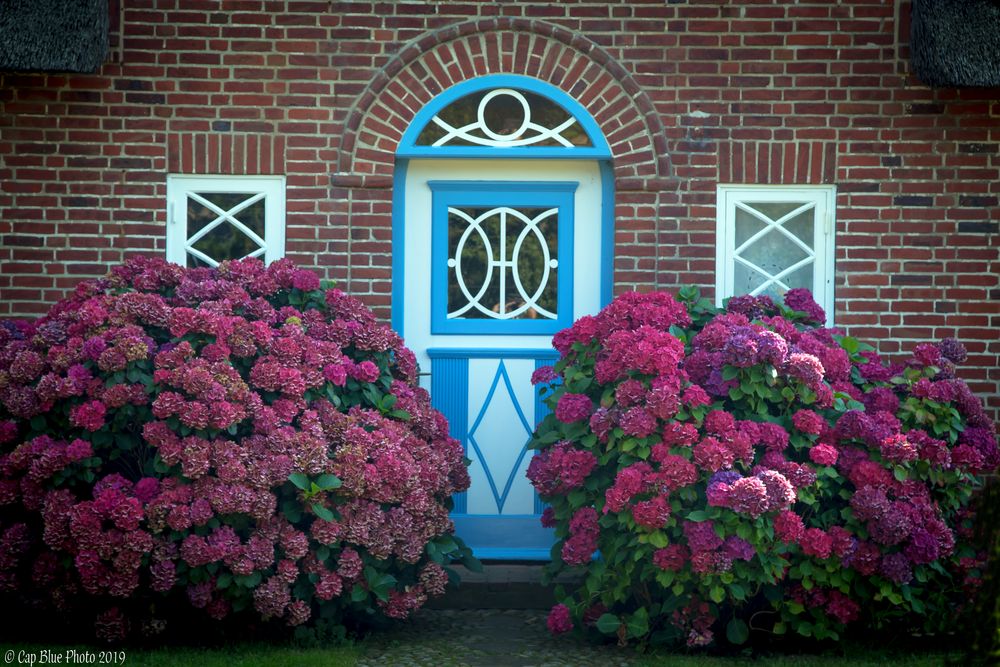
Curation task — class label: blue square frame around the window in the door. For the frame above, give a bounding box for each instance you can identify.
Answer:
[427,181,579,335]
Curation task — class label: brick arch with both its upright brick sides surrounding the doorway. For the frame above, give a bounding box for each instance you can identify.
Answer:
[330,18,681,318]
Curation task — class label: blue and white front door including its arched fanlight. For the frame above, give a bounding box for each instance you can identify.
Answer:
[392,75,614,560]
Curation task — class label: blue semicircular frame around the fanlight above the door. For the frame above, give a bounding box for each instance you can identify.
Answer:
[396,74,611,160]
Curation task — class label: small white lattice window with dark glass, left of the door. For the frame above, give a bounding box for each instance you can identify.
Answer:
[167,175,285,268]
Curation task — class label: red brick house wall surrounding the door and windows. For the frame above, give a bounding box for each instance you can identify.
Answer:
[0,0,1000,418]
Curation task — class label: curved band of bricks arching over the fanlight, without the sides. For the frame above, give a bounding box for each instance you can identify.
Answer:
[334,18,671,191]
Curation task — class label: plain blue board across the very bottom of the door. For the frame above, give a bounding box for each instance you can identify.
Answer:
[451,514,555,560]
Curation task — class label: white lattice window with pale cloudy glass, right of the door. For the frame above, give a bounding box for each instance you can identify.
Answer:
[715,185,836,326]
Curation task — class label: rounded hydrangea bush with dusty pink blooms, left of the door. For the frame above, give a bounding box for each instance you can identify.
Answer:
[0,258,471,639]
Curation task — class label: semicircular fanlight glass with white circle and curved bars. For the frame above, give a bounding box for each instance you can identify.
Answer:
[416,88,592,147]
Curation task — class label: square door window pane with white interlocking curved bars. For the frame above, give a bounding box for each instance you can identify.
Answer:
[448,206,559,320]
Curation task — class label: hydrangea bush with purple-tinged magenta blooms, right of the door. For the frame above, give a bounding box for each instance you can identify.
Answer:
[528,289,1000,646]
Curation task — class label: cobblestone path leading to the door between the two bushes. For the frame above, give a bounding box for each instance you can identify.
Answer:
[357,608,634,667]
